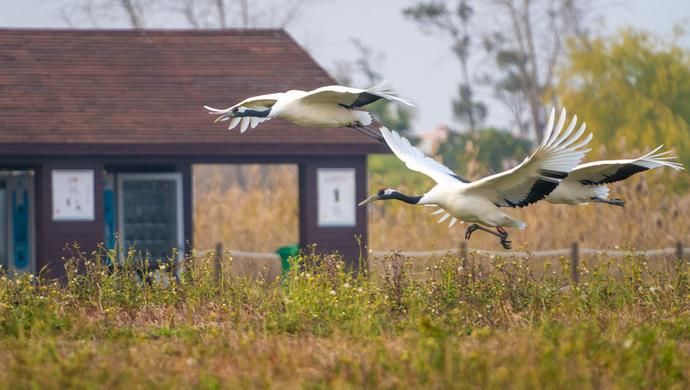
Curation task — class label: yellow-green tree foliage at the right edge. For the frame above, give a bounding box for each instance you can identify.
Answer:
[558,30,690,166]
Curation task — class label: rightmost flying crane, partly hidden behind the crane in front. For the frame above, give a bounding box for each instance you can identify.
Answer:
[546,145,684,207]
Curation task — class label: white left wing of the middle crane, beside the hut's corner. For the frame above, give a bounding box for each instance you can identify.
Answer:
[381,127,467,184]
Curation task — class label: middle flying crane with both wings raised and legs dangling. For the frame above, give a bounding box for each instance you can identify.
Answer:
[359,109,592,249]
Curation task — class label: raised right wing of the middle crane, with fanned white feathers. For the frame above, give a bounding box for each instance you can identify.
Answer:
[465,109,592,207]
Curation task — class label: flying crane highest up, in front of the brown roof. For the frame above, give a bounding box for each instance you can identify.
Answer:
[204,84,413,142]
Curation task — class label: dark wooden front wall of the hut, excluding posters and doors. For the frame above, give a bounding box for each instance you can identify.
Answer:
[0,155,368,278]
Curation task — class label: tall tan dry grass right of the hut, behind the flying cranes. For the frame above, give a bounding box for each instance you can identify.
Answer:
[369,172,690,250]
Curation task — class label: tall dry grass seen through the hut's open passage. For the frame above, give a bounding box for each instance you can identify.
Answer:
[194,165,299,252]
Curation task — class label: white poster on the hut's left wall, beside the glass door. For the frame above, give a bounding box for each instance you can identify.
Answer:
[52,169,95,221]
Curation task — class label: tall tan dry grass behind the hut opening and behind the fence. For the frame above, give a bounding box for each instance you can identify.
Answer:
[194,161,690,251]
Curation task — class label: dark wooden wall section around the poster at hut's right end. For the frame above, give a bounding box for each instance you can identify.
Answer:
[299,156,368,268]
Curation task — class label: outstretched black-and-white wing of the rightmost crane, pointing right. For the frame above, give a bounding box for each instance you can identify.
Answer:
[566,145,684,185]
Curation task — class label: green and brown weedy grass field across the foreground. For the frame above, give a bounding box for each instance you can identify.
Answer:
[0,250,690,389]
